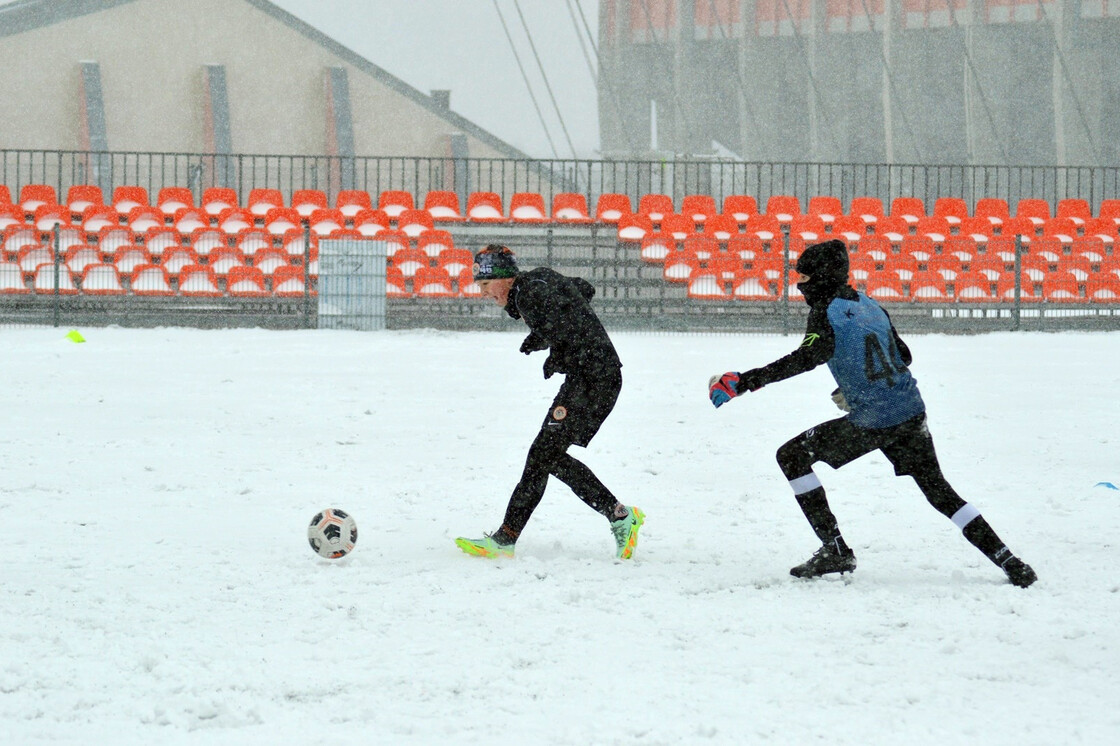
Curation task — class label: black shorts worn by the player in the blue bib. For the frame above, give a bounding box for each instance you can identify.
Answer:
[794,412,941,476]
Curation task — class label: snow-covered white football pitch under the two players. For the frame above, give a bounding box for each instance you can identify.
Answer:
[0,328,1120,746]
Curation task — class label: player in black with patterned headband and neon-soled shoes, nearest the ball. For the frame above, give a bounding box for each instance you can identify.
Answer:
[455,244,645,559]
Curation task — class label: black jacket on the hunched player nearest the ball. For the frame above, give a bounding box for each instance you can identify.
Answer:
[505,267,622,377]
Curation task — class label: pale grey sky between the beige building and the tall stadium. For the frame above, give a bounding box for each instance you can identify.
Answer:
[272,0,599,158]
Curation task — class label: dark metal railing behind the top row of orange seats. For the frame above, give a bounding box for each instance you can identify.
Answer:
[0,150,1120,211]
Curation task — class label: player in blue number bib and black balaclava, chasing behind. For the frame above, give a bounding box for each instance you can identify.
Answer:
[708,240,1037,588]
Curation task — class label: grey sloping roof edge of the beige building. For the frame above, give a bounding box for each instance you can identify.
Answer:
[0,0,529,159]
